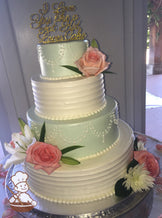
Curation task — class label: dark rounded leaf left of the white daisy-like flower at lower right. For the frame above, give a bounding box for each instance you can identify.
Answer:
[115,178,132,197]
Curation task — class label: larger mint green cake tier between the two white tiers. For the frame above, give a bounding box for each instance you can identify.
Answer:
[27,97,119,159]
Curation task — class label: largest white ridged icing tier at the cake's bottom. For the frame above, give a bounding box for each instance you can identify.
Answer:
[25,121,134,204]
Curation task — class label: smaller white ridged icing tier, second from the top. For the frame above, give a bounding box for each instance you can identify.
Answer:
[32,74,106,120]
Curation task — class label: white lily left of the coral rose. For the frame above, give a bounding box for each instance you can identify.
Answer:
[4,125,36,169]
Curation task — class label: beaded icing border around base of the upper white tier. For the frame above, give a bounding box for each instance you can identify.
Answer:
[34,100,107,120]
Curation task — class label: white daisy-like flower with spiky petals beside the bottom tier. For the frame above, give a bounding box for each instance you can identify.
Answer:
[123,164,154,192]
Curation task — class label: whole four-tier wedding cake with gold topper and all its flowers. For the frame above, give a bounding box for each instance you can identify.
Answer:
[4,2,159,217]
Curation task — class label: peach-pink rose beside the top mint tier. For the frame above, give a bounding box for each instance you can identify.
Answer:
[75,47,110,77]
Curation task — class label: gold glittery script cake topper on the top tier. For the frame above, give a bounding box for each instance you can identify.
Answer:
[30,2,87,44]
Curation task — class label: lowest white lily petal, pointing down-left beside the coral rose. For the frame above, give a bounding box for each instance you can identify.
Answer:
[3,152,26,169]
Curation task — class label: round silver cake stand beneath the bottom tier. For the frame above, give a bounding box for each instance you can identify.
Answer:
[5,164,153,218]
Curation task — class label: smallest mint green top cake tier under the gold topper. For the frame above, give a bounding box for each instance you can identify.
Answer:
[37,40,88,80]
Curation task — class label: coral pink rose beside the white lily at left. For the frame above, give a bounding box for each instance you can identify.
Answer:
[26,142,62,174]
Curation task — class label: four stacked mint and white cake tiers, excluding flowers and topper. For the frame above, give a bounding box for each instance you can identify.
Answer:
[25,38,134,204]
